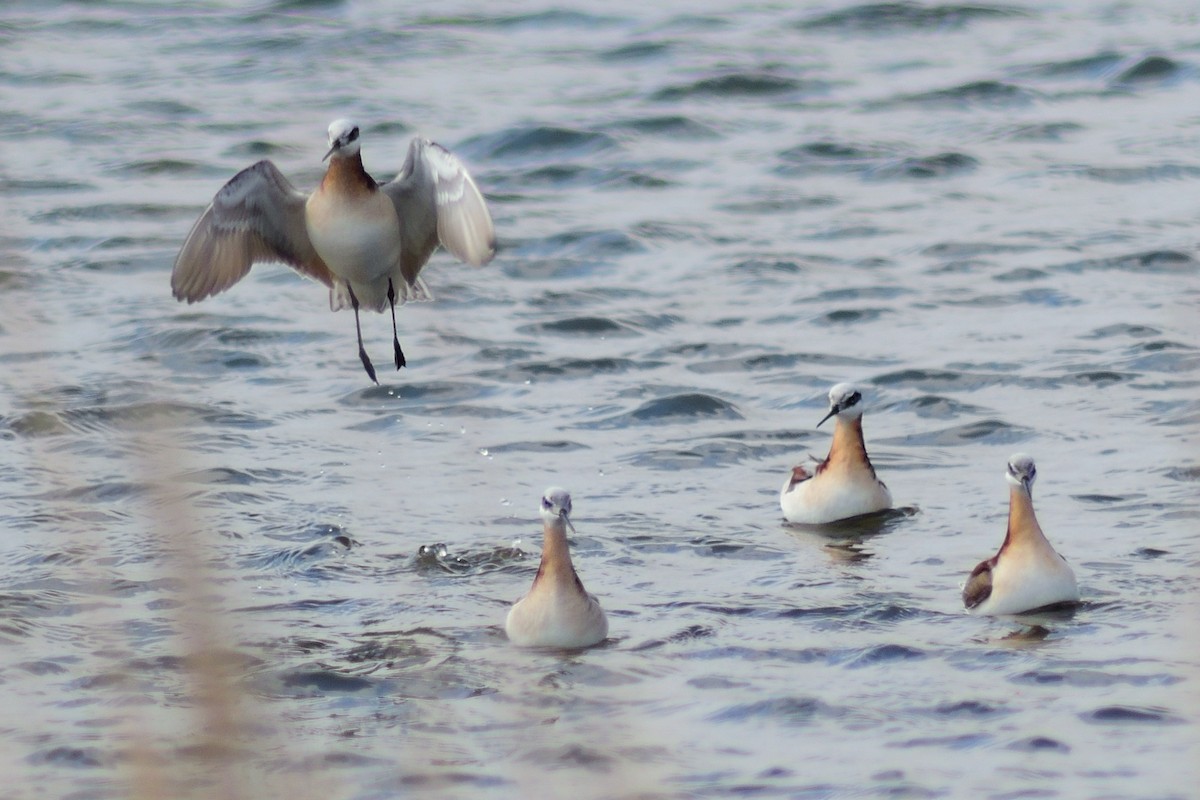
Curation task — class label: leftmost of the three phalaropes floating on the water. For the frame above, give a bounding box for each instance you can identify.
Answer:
[504,488,608,649]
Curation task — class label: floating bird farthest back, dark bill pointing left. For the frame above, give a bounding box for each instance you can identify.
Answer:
[779,384,892,525]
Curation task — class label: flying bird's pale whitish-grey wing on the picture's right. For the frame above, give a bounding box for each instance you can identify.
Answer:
[380,137,496,284]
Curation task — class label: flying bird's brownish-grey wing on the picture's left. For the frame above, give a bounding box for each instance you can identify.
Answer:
[170,160,334,302]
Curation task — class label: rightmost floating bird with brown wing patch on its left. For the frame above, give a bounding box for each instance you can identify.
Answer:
[962,453,1079,615]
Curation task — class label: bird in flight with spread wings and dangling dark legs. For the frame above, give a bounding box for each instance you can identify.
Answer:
[170,119,496,383]
